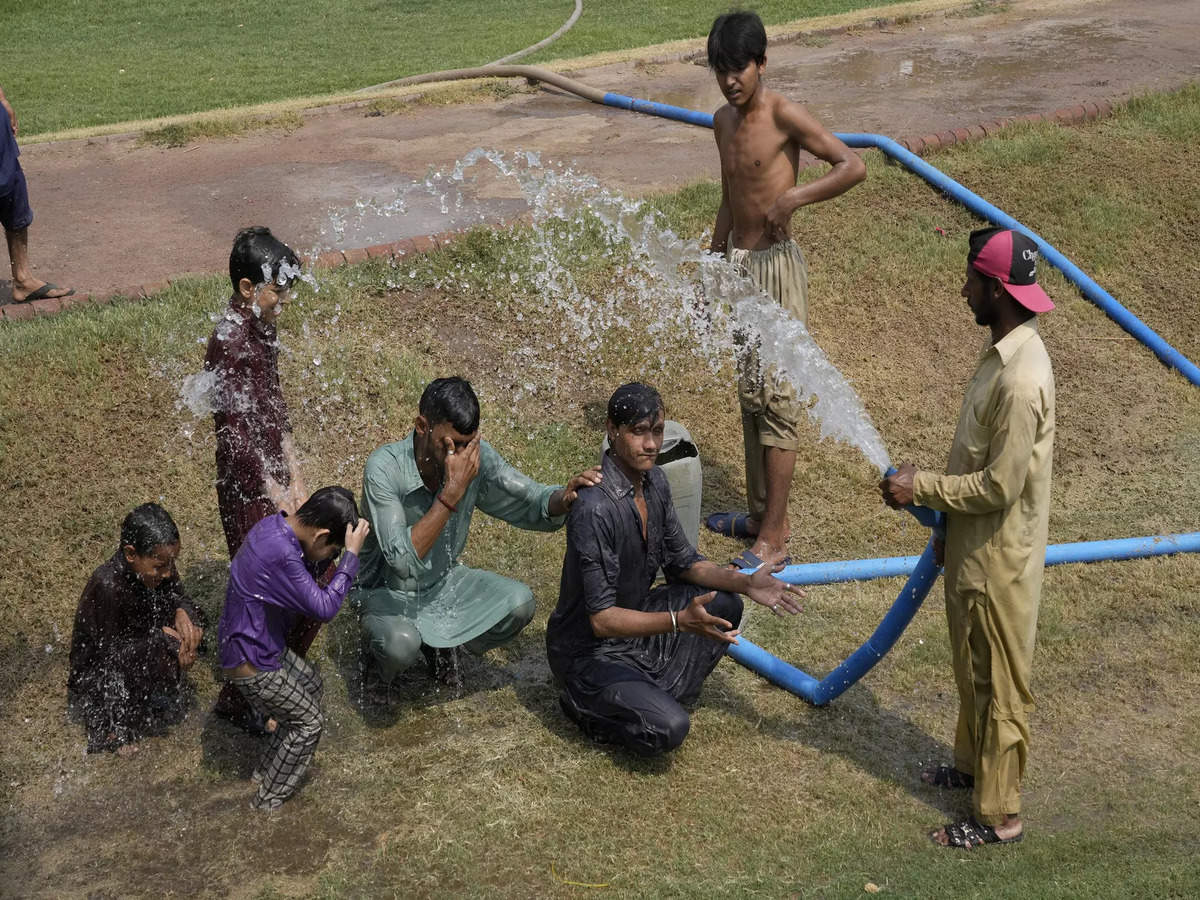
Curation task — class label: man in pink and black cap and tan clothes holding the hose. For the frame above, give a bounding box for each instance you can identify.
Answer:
[880,228,1055,850]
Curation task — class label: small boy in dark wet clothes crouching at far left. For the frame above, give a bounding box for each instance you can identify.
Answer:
[67,503,204,755]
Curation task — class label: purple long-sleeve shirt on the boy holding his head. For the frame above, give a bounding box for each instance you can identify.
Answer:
[217,512,359,671]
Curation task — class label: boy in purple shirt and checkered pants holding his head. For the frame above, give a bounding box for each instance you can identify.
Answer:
[218,487,371,810]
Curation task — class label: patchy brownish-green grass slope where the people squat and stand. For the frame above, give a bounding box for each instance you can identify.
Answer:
[0,86,1200,899]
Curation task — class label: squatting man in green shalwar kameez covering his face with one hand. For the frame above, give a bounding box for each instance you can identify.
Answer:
[356,378,600,682]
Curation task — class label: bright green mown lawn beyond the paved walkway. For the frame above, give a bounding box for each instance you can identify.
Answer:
[0,0,912,136]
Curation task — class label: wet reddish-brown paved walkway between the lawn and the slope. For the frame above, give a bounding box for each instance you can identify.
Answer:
[0,0,1200,302]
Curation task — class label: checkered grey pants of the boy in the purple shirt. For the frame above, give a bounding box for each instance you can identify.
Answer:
[230,650,324,810]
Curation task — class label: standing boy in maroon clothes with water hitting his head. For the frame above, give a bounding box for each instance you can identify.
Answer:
[204,226,320,731]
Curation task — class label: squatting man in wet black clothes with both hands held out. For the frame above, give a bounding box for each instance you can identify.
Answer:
[546,383,803,756]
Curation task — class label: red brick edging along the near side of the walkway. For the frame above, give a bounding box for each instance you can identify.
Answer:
[0,100,1112,322]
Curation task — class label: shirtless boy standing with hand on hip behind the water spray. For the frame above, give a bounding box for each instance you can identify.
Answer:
[707,12,866,565]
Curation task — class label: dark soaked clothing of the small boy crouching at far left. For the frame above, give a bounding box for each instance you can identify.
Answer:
[67,551,204,752]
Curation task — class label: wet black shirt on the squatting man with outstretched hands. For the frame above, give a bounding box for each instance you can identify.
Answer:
[546,454,703,674]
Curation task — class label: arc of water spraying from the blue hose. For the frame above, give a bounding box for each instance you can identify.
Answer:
[164,148,888,501]
